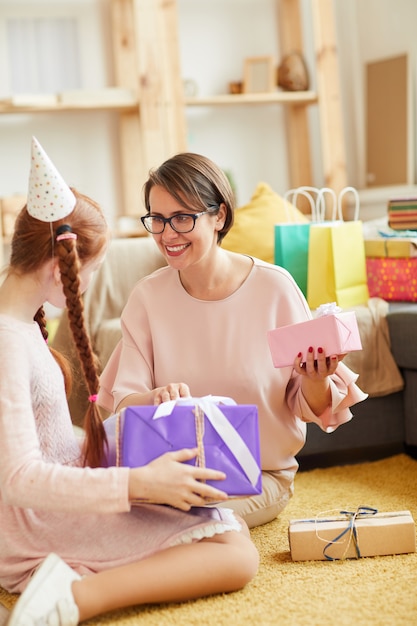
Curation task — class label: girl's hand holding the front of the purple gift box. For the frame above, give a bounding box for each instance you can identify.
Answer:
[129,448,228,511]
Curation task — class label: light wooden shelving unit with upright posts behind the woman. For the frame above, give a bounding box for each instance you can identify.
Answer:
[0,0,346,232]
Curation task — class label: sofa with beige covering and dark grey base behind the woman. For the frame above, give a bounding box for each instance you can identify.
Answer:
[52,236,406,466]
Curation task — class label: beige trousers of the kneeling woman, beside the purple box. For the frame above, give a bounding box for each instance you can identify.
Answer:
[216,470,295,528]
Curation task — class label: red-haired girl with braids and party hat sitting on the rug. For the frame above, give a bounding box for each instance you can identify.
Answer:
[0,140,258,626]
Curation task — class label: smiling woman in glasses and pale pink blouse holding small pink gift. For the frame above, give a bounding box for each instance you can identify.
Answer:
[99,153,366,527]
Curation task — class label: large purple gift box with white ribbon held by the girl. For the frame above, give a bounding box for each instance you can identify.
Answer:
[104,396,262,496]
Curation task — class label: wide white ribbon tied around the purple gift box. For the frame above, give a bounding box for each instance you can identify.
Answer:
[153,395,261,485]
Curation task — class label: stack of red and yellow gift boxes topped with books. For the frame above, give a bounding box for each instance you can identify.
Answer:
[365,198,417,302]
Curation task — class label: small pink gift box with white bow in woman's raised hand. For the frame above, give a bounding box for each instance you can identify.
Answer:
[268,311,362,367]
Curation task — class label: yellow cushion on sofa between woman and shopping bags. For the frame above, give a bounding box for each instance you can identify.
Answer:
[222,183,309,263]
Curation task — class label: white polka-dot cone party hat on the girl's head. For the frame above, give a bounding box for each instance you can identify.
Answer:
[27,137,76,222]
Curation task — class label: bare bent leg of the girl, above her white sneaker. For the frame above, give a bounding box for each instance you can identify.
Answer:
[72,531,259,621]
